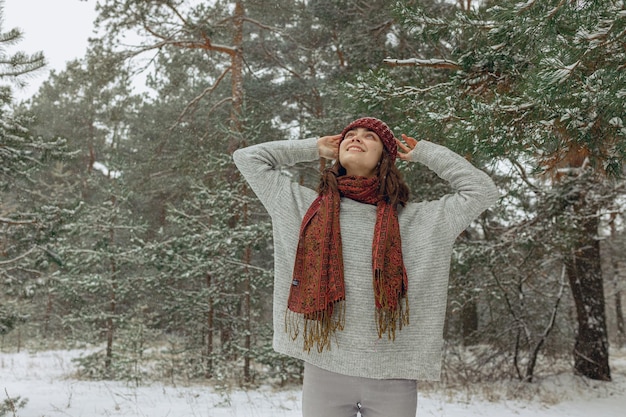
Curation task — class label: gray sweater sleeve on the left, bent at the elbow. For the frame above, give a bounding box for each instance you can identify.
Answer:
[233,138,319,217]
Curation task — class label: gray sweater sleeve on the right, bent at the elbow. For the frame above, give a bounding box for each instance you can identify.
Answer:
[411,140,498,236]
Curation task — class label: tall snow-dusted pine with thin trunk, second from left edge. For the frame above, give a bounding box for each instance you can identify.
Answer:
[22,43,148,379]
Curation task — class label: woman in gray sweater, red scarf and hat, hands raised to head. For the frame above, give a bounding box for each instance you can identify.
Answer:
[234,117,497,417]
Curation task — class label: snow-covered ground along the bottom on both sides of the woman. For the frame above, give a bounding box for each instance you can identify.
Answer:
[0,351,626,417]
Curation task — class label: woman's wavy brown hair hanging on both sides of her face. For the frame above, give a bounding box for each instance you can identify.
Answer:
[317,149,409,207]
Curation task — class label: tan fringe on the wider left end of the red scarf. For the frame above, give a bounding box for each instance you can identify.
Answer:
[285,300,346,353]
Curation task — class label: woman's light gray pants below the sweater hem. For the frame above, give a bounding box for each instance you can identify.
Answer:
[302,363,417,417]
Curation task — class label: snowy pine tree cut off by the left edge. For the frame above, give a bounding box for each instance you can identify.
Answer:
[0,4,64,347]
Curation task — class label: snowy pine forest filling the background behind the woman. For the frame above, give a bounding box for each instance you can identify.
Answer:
[0,0,626,404]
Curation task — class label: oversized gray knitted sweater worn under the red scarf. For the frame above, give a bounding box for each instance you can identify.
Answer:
[233,138,498,380]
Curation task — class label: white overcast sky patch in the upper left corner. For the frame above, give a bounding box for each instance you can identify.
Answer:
[0,0,96,100]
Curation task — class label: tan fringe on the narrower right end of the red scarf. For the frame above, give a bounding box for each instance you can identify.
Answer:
[374,271,409,341]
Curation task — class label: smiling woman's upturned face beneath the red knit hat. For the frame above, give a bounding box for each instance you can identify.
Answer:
[339,127,383,178]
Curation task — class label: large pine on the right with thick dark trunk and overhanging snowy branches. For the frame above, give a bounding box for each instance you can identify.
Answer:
[352,0,626,380]
